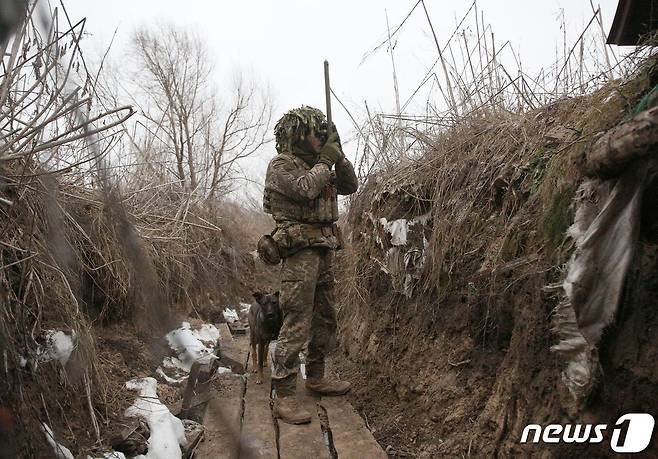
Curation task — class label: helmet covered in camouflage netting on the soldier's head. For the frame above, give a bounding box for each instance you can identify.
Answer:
[274,105,327,153]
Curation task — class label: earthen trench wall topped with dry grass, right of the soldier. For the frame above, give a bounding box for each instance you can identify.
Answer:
[336,70,658,457]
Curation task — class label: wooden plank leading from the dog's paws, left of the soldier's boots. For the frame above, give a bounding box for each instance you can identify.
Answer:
[240,359,277,458]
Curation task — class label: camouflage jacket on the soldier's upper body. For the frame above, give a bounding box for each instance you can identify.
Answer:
[263,152,358,256]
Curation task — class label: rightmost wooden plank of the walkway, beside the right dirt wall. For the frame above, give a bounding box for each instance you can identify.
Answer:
[320,397,388,459]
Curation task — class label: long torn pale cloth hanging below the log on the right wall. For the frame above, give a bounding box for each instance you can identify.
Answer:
[551,164,648,401]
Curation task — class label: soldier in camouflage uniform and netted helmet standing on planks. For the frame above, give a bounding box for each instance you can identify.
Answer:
[263,106,358,424]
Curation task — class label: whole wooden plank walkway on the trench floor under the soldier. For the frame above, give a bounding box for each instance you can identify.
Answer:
[195,326,387,459]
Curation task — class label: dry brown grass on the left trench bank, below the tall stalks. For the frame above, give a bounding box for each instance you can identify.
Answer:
[0,161,266,455]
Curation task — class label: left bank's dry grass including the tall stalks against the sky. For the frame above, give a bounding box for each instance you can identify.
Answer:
[0,3,267,457]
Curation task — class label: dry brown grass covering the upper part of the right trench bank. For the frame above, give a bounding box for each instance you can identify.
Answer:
[343,47,655,330]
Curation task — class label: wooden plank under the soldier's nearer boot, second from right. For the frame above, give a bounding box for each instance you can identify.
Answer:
[279,375,328,459]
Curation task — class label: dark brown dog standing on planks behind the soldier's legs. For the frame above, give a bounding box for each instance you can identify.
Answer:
[248,292,283,384]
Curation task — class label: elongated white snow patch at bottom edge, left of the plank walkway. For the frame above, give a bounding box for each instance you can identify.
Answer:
[124,378,187,459]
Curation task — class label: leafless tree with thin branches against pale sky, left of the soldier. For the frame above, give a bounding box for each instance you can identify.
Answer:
[128,25,272,198]
